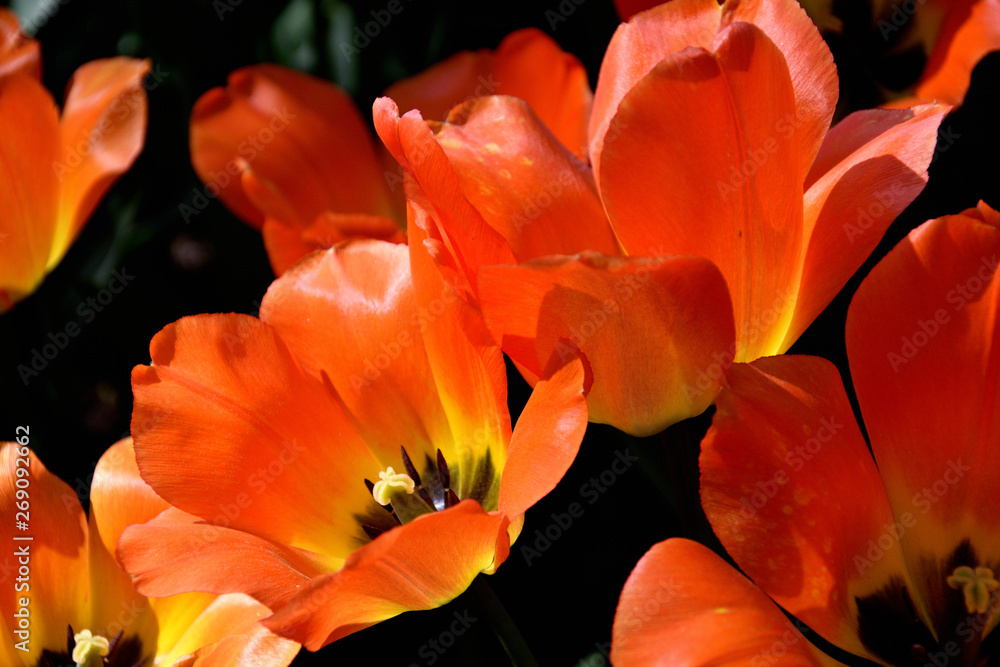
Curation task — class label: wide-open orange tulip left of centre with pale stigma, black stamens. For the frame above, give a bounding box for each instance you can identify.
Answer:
[119,203,587,650]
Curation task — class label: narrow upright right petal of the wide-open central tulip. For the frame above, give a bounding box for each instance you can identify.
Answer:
[500,354,592,518]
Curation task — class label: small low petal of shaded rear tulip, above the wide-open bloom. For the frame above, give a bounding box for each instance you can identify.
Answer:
[261,211,406,276]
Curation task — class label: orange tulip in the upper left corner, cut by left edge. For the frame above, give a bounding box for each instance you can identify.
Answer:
[0,8,149,313]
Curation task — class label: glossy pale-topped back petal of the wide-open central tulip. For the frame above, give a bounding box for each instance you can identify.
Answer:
[261,241,458,470]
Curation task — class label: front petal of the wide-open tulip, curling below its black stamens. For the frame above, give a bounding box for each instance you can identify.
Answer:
[264,500,510,651]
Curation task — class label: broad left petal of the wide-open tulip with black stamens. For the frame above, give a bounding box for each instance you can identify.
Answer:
[132,315,384,558]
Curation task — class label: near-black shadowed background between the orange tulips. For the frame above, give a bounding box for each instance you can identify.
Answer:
[0,0,1000,667]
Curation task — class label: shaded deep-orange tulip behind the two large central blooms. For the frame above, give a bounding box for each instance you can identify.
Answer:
[190,28,591,275]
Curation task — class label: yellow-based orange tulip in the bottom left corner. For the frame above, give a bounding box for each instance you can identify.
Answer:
[0,440,300,667]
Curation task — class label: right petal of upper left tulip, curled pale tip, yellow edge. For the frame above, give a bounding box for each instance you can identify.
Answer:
[48,57,150,270]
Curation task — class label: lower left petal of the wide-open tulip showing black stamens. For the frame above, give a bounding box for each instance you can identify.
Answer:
[117,503,326,607]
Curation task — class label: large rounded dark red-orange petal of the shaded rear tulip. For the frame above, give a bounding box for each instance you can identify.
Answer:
[191,64,402,232]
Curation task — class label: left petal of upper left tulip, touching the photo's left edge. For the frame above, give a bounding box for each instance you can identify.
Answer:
[0,74,59,313]
